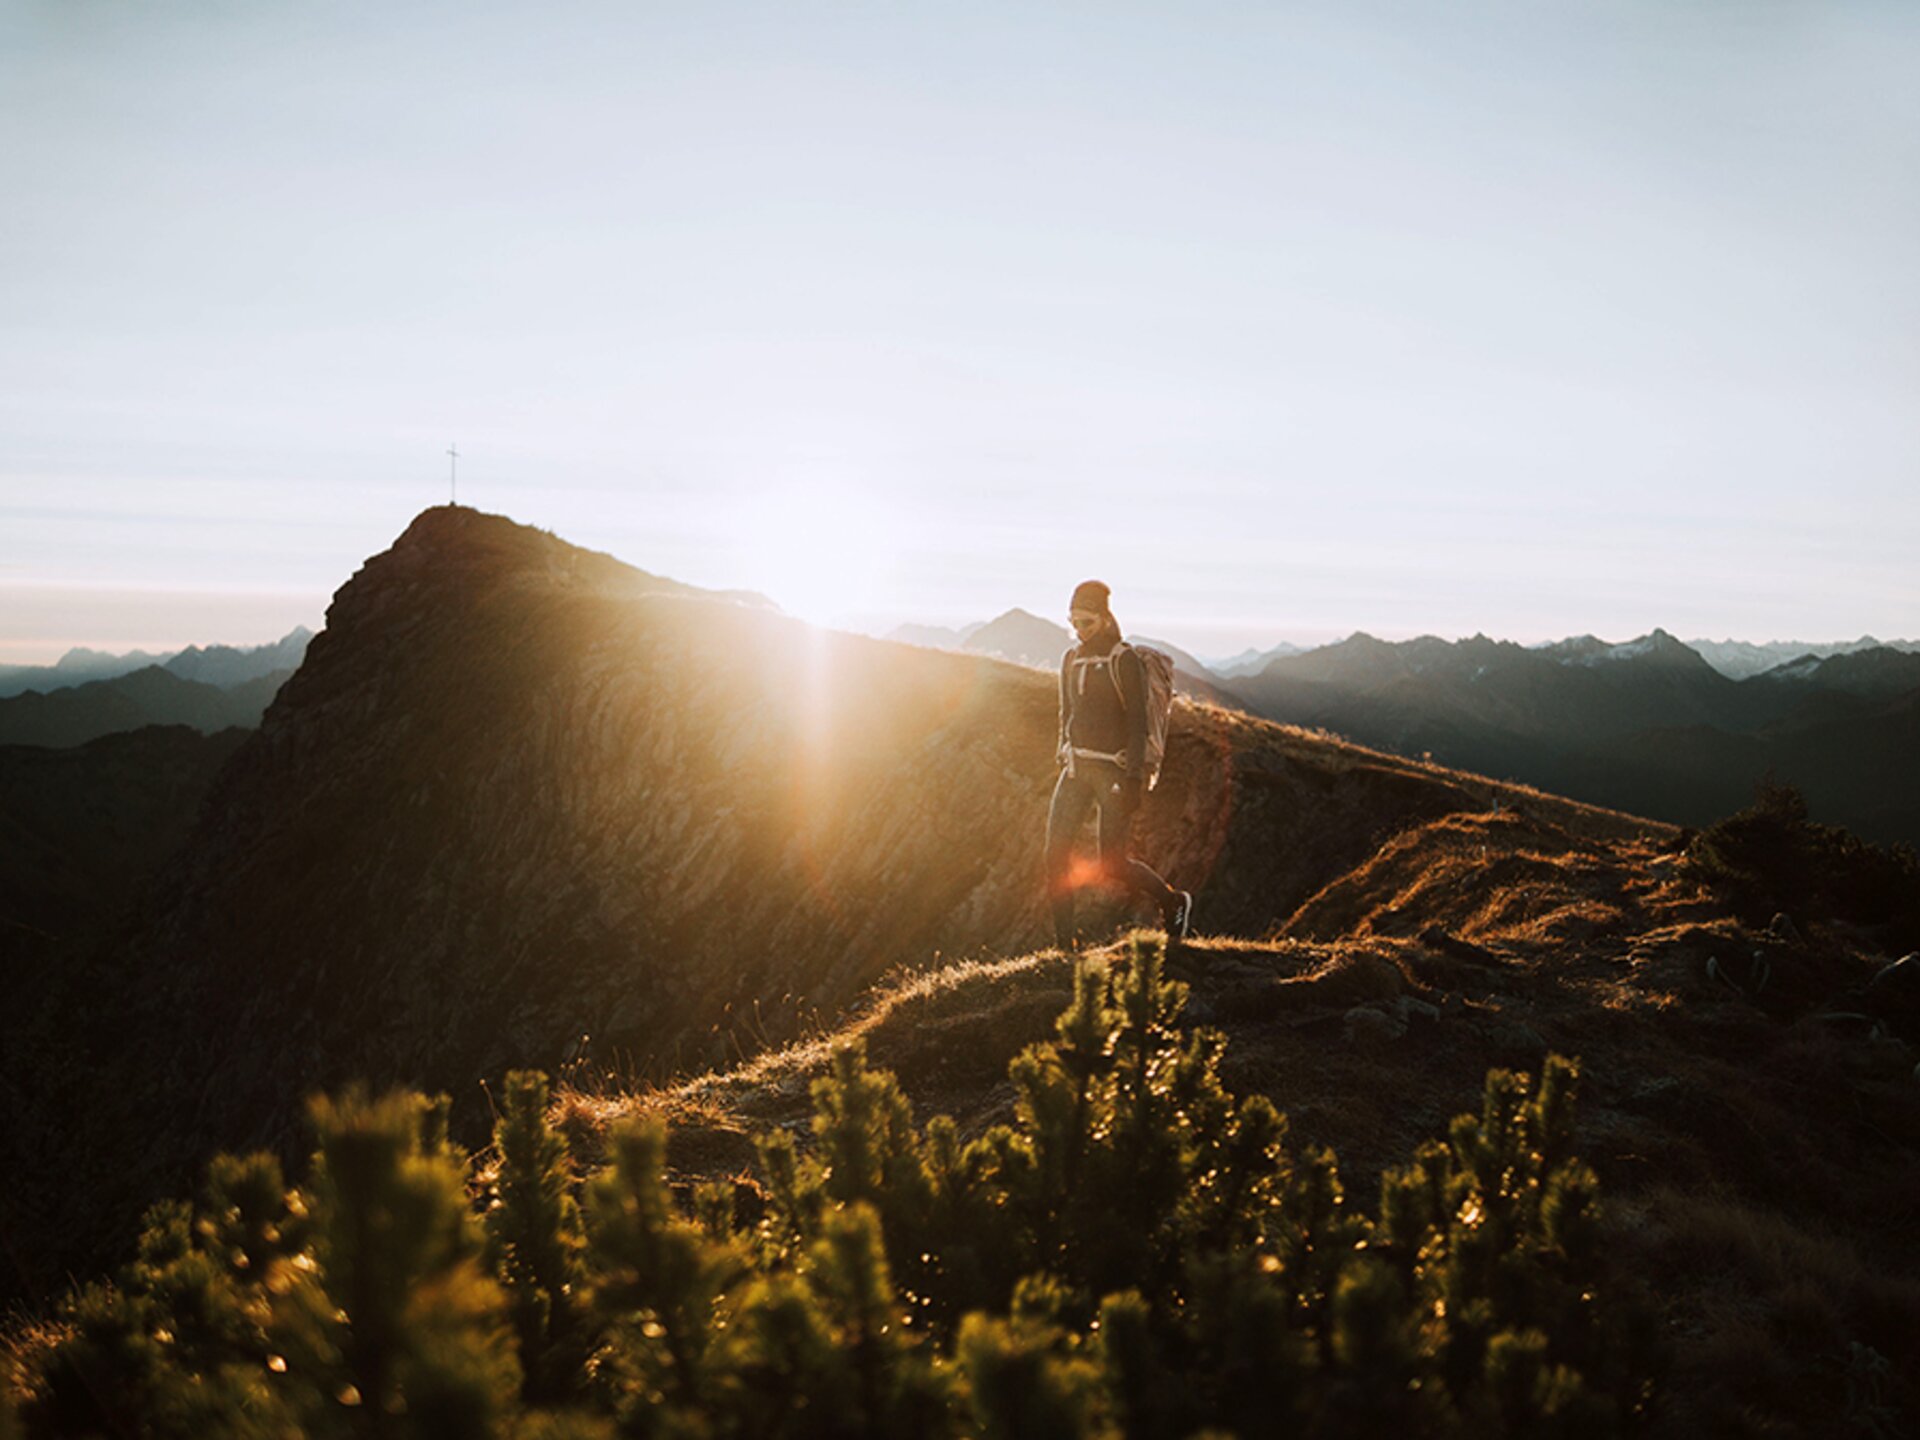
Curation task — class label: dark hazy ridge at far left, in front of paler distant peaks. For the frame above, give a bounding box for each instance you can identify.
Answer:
[0,664,292,745]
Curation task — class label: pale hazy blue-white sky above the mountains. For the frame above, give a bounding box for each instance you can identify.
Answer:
[0,0,1920,660]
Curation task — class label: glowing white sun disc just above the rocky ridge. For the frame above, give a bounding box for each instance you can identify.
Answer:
[733,484,900,624]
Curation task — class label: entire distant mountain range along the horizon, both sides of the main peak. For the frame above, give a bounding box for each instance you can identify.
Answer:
[15,593,1920,843]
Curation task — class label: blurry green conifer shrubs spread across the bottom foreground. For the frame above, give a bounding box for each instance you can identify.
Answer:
[21,945,1653,1440]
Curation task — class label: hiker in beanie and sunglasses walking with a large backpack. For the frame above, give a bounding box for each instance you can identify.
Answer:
[1046,580,1194,948]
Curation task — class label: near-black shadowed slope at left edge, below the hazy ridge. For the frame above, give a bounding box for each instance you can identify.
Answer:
[0,726,246,1300]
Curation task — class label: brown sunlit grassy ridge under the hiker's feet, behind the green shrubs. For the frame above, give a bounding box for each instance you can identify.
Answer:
[557,806,1920,1434]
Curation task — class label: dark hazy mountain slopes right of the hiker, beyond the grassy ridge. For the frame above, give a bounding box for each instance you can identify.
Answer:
[1231,630,1920,841]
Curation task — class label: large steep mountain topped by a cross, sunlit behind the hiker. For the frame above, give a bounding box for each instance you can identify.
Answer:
[7,507,1647,1305]
